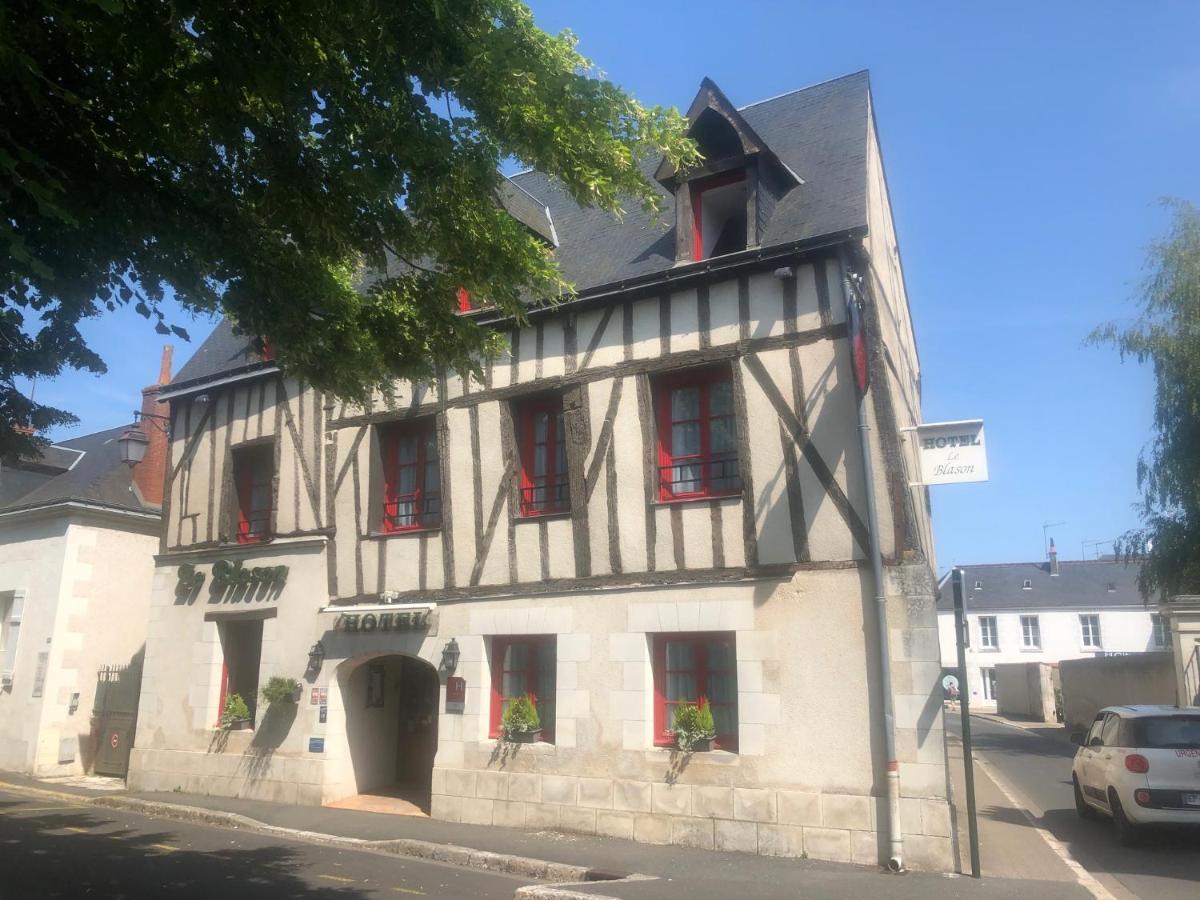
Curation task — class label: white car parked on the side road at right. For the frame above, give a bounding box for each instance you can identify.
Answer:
[1072,706,1200,845]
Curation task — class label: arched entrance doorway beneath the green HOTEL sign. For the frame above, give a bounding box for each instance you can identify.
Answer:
[335,654,439,815]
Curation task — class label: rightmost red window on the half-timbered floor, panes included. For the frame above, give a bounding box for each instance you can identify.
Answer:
[655,367,742,500]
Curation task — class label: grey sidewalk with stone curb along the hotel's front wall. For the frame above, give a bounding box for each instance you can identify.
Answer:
[0,773,1086,900]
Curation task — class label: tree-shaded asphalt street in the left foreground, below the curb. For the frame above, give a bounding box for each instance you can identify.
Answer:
[0,791,529,900]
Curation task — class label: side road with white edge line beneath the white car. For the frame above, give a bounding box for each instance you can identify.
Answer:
[946,713,1200,900]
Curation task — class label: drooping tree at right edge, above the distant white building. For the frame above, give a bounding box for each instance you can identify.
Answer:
[1090,200,1200,601]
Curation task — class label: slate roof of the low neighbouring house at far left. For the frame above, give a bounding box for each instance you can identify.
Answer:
[0,425,160,512]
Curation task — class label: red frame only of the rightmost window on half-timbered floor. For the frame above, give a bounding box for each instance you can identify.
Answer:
[654,366,742,500]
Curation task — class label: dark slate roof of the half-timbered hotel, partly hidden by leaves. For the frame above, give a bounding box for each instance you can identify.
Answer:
[170,71,870,388]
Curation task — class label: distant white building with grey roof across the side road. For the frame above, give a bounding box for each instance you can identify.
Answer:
[937,552,1169,709]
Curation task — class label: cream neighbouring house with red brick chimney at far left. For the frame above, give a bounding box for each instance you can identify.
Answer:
[0,353,170,775]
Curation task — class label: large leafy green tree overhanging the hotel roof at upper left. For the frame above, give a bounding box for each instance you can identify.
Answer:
[0,0,697,455]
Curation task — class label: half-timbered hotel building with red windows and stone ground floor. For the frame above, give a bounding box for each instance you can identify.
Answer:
[132,73,952,868]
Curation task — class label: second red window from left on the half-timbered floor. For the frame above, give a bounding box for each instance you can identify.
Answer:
[379,416,442,532]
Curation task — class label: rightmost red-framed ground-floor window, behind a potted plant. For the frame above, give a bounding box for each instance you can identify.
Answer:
[653,631,738,751]
